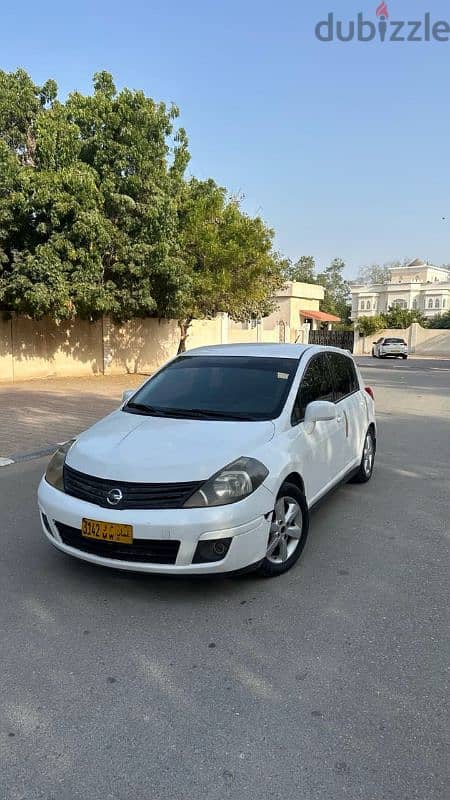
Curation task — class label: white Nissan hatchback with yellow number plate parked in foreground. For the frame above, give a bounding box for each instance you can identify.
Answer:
[39,344,376,576]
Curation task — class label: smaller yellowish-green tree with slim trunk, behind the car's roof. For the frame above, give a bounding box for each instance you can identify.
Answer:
[169,178,286,352]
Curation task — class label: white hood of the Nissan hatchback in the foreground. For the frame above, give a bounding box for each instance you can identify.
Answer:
[67,410,275,483]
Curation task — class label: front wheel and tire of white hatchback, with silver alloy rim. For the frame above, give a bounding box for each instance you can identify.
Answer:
[256,482,309,578]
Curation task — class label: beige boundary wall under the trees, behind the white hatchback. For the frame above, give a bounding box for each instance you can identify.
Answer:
[0,314,279,382]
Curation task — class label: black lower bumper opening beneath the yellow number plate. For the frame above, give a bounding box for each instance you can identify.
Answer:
[55,522,180,564]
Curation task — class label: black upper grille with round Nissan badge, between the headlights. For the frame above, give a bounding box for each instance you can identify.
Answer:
[64,465,203,511]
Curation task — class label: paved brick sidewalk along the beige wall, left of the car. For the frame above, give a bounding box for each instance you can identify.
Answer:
[0,375,147,465]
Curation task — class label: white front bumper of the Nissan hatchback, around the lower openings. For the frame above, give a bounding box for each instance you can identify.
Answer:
[38,478,274,575]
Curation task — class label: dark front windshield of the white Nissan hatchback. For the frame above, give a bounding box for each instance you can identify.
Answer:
[123,355,298,421]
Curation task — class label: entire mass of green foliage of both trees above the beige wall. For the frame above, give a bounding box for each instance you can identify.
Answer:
[0,70,285,344]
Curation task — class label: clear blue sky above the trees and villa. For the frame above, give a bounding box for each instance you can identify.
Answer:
[0,0,450,277]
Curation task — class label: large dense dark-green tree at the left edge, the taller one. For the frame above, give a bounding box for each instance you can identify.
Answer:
[0,70,189,319]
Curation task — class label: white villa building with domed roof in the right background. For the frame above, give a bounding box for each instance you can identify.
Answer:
[351,258,450,320]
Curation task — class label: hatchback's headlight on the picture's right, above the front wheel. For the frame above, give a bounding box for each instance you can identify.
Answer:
[184,457,269,508]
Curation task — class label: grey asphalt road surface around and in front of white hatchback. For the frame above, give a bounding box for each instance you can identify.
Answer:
[0,359,450,800]
